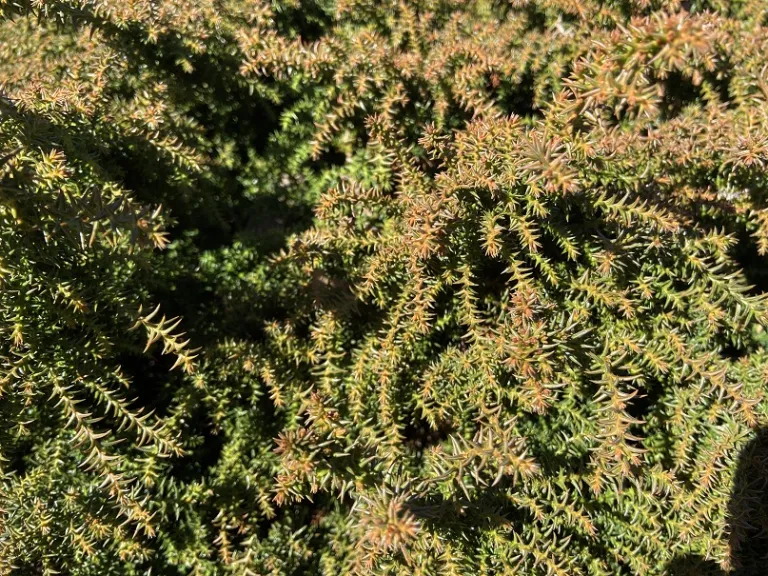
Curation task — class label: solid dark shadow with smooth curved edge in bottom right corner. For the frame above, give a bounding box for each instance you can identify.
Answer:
[667,428,768,576]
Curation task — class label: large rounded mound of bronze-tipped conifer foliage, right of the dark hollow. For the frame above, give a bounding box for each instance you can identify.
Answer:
[278,104,768,574]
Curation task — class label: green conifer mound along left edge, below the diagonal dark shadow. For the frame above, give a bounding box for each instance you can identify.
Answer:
[0,64,186,570]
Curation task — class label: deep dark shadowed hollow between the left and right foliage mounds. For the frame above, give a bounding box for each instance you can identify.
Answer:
[0,2,345,490]
